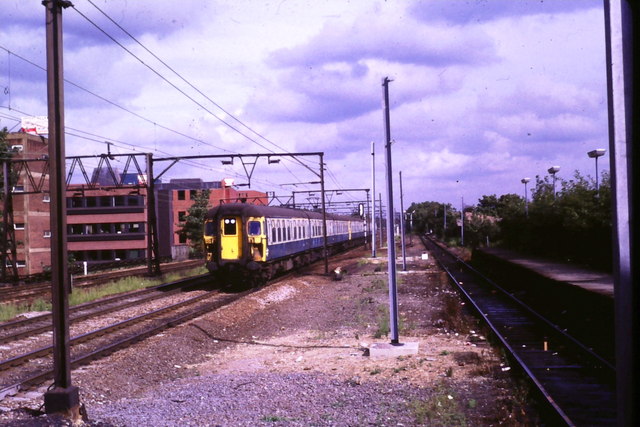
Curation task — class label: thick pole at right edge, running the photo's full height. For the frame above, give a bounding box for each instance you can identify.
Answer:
[604,0,640,426]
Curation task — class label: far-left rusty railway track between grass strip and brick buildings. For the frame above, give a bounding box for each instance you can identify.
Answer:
[0,260,202,303]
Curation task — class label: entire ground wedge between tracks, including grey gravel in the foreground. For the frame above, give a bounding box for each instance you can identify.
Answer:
[0,245,538,427]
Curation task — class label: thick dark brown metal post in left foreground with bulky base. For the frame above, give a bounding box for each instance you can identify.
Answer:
[43,0,80,413]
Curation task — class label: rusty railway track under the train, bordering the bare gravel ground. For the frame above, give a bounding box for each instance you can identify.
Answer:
[0,275,252,400]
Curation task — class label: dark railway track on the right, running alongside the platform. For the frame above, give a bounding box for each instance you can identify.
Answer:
[423,238,616,426]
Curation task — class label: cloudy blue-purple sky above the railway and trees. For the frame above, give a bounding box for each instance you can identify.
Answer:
[0,0,609,211]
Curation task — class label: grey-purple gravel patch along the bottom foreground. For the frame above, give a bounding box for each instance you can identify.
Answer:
[88,373,426,426]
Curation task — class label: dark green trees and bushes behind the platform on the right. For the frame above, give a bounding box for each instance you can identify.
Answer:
[407,171,612,271]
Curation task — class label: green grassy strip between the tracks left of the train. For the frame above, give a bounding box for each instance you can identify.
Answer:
[0,267,205,322]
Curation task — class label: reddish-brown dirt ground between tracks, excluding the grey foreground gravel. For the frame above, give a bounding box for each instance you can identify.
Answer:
[0,243,536,426]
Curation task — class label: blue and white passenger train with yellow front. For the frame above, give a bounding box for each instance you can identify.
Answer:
[203,203,366,286]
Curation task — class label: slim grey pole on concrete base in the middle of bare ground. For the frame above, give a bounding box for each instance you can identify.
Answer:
[382,77,400,344]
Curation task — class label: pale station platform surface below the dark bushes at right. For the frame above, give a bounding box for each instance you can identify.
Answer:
[474,248,614,299]
